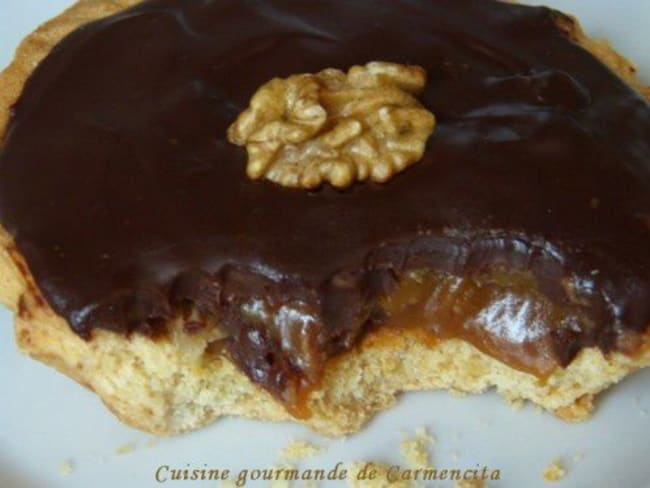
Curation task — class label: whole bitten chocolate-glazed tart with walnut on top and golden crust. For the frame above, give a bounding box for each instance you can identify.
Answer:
[0,0,650,435]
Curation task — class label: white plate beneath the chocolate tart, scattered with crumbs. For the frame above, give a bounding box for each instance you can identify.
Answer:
[0,0,650,488]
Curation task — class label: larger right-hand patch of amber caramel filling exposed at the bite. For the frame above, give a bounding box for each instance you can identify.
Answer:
[385,271,580,378]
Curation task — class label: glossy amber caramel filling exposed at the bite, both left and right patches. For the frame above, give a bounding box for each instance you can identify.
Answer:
[230,270,600,418]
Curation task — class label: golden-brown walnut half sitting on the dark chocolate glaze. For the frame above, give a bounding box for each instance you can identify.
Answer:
[228,62,435,189]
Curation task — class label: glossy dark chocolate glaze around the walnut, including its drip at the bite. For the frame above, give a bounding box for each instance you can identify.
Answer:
[0,0,650,399]
